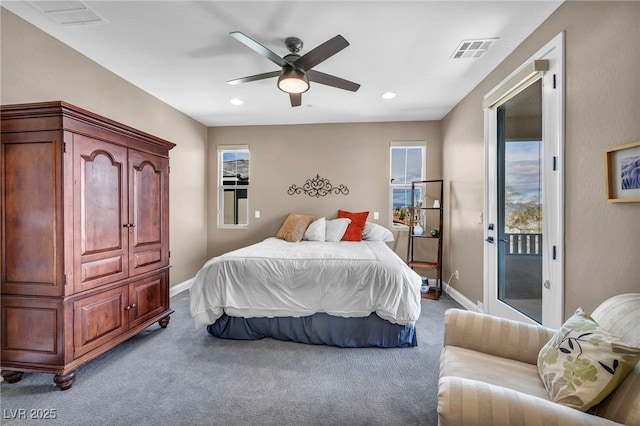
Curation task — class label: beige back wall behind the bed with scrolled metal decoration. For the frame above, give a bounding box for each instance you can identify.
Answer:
[208,121,442,258]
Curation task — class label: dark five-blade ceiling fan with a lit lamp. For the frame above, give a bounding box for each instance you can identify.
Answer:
[227,31,360,107]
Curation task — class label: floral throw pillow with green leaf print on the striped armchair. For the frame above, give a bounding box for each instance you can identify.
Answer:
[538,308,640,411]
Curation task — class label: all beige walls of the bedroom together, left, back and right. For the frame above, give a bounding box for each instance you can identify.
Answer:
[0,1,640,316]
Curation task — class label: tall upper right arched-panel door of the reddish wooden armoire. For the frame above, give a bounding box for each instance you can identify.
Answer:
[129,150,169,275]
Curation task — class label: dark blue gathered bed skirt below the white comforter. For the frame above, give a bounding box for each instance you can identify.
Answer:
[207,313,418,348]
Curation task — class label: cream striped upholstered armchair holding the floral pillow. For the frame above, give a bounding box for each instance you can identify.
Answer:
[438,293,640,426]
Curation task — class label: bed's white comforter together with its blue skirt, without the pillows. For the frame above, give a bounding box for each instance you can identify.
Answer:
[190,218,421,347]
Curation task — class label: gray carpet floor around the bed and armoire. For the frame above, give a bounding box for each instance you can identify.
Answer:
[0,291,460,426]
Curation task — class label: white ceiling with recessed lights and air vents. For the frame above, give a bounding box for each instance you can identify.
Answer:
[2,0,562,126]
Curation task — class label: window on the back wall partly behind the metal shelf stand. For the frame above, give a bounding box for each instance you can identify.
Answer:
[390,142,426,230]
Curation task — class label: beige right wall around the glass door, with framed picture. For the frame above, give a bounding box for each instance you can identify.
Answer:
[442,1,640,317]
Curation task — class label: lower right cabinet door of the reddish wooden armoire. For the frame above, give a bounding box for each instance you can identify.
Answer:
[129,271,169,328]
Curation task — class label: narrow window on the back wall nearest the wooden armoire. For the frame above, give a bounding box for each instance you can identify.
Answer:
[218,145,249,227]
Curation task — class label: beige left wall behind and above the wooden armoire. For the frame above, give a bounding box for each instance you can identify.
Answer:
[0,9,207,284]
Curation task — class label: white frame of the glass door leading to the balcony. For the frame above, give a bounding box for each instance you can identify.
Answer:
[483,32,565,328]
